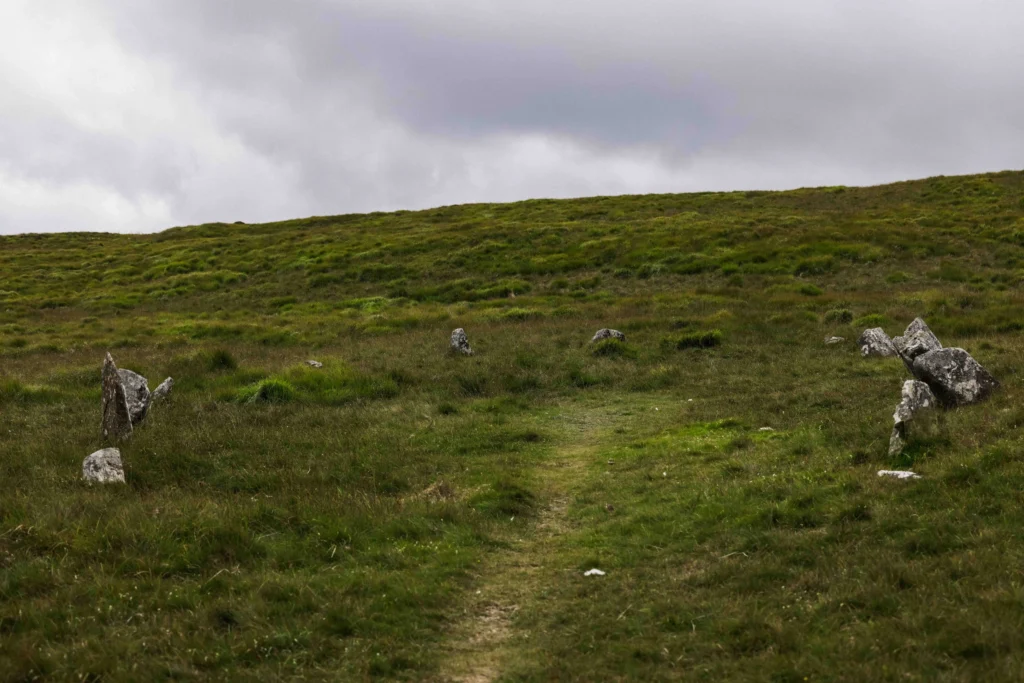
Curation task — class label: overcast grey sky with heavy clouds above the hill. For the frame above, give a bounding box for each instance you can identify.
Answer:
[0,0,1024,233]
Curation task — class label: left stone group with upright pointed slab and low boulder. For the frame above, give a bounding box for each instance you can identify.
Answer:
[82,353,174,483]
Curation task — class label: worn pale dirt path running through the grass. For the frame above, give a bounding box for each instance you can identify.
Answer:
[441,396,667,683]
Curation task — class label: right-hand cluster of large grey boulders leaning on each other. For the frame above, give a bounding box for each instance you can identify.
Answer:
[857,317,999,456]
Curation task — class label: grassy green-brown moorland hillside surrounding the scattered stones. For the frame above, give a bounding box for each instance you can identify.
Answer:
[0,173,1024,681]
